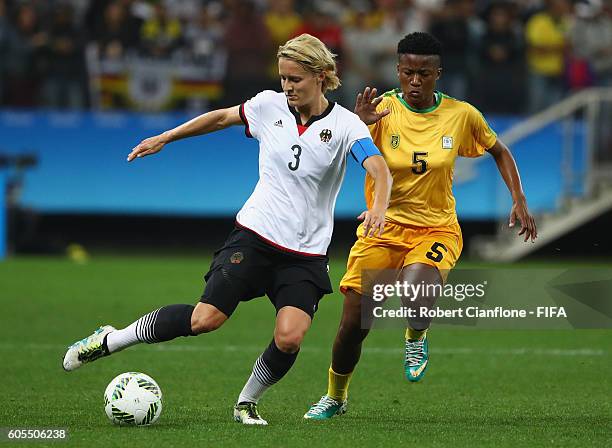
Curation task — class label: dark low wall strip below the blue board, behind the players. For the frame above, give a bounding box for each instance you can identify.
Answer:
[16,213,612,261]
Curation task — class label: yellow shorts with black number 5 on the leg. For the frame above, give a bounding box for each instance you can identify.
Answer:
[340,221,463,294]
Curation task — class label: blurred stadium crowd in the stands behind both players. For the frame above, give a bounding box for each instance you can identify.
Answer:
[0,0,612,114]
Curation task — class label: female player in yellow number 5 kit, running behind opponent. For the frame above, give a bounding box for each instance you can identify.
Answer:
[304,33,537,419]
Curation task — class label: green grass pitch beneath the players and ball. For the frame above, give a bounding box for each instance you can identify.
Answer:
[0,256,612,448]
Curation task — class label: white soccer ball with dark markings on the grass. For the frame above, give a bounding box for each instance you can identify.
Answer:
[104,372,162,426]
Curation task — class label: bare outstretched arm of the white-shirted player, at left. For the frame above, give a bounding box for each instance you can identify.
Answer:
[127,106,242,162]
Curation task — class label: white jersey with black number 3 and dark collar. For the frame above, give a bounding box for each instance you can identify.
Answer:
[236,90,370,255]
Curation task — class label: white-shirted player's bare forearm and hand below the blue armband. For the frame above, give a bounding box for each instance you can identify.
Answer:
[357,156,393,236]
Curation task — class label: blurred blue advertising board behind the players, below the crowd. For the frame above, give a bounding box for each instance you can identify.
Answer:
[0,110,585,219]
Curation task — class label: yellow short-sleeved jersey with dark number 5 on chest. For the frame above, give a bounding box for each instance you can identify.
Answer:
[365,89,497,227]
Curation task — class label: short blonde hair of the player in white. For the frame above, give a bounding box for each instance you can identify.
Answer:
[276,34,340,93]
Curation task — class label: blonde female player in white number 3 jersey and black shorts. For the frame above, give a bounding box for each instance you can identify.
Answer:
[63,34,392,425]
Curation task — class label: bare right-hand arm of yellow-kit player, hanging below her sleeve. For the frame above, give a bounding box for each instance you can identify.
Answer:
[487,140,538,242]
